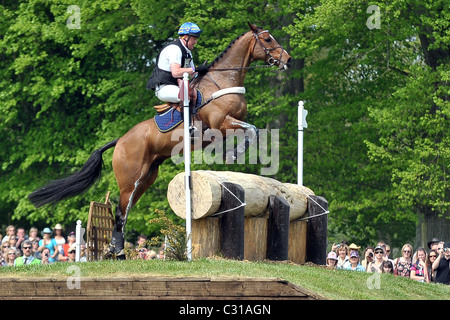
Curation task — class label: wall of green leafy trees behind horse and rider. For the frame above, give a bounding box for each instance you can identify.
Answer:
[0,0,450,247]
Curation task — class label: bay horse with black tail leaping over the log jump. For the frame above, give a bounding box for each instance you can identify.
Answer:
[28,23,292,259]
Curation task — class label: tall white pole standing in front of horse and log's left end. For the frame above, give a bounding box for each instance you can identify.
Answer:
[183,72,192,261]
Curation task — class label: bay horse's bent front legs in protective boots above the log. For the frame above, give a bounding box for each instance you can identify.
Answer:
[220,116,258,164]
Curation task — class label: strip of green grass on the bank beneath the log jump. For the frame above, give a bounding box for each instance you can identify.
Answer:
[0,259,450,300]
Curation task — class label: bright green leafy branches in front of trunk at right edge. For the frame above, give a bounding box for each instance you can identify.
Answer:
[368,65,450,215]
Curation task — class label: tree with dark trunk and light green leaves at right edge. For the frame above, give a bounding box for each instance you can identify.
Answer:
[368,1,450,246]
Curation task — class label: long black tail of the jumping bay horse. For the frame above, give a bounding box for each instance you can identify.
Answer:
[28,139,119,207]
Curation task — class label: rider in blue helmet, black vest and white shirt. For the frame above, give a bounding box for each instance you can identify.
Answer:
[147,22,207,103]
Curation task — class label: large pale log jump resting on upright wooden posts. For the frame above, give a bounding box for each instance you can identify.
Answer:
[167,170,328,264]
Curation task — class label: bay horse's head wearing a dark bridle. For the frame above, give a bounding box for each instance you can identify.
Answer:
[248,23,292,70]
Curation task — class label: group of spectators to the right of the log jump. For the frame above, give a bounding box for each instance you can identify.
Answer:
[326,238,450,285]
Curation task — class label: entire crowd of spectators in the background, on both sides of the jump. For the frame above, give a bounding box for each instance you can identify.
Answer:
[0,223,450,285]
